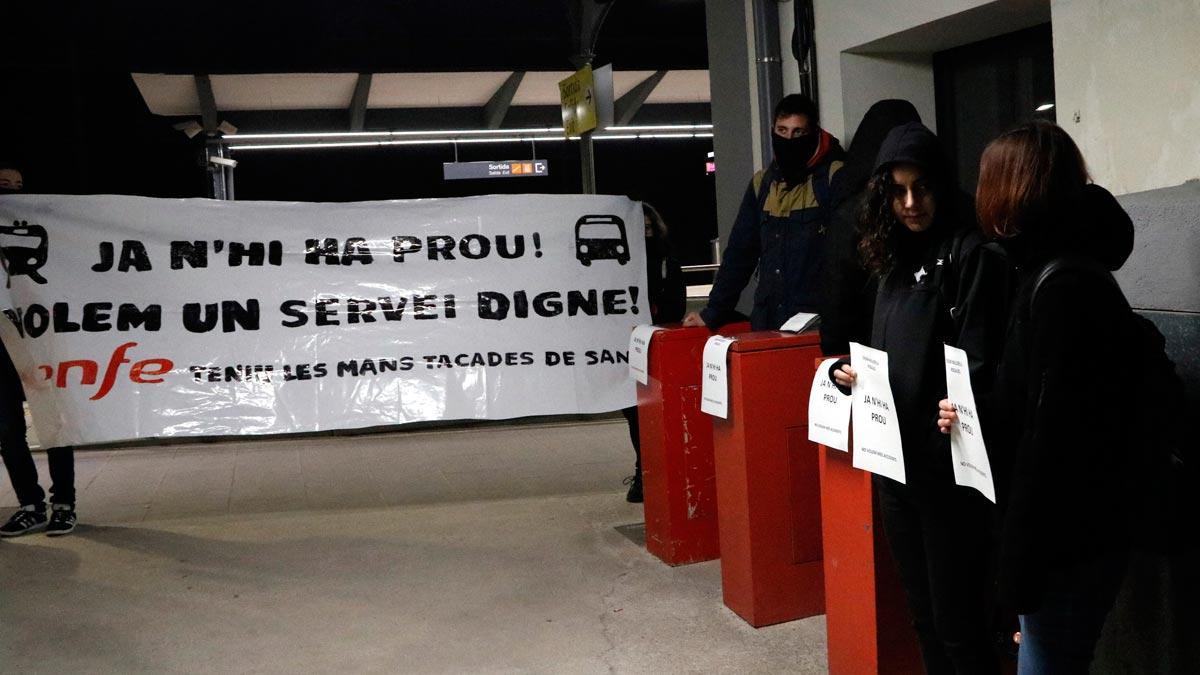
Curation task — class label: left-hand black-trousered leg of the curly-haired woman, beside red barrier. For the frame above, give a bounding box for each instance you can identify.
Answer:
[874,477,954,675]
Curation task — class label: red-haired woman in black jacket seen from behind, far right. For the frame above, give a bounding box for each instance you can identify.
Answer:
[940,123,1132,674]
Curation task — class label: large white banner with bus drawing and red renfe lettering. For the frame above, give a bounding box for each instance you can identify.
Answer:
[0,196,649,446]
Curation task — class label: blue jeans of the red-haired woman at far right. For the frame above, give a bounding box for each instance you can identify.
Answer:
[1016,551,1129,675]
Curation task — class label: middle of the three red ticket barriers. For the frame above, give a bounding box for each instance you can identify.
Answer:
[713,331,824,627]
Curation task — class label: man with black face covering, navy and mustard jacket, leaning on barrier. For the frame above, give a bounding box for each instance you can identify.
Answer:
[683,94,845,330]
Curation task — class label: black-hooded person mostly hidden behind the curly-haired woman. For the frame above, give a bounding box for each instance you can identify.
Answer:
[821,98,920,354]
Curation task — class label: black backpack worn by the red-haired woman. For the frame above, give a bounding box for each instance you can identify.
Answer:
[1030,258,1200,555]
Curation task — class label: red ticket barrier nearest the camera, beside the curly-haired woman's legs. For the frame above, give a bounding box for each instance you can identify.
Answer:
[818,437,924,675]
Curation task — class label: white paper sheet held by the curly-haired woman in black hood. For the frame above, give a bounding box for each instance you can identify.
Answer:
[850,342,905,483]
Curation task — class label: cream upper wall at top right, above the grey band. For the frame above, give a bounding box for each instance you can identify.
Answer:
[1051,0,1200,194]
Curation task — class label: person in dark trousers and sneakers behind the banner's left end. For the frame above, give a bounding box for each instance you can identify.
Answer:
[0,163,76,537]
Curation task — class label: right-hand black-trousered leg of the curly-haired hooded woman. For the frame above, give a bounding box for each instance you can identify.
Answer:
[922,486,1000,675]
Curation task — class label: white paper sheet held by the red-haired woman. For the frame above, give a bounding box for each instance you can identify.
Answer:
[943,345,996,503]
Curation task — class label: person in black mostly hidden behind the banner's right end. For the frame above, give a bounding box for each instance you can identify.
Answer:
[620,203,688,503]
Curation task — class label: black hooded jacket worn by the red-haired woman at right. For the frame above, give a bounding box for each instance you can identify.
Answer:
[980,185,1136,613]
